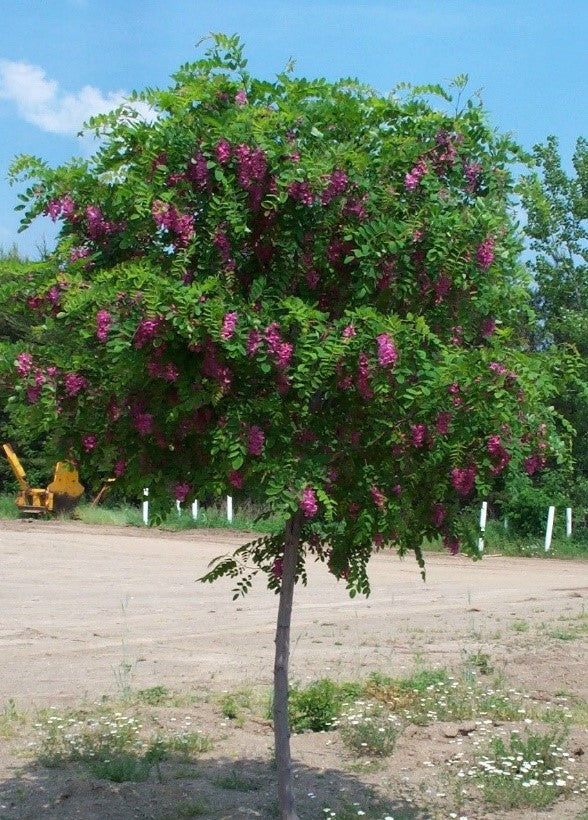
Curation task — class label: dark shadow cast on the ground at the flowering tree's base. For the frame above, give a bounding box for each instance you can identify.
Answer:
[0,757,430,820]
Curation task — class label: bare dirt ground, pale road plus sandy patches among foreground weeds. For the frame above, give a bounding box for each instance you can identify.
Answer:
[0,520,588,820]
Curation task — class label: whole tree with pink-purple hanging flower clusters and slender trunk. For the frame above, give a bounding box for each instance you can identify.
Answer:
[4,36,558,818]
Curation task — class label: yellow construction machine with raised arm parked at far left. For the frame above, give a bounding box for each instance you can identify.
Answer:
[2,444,84,515]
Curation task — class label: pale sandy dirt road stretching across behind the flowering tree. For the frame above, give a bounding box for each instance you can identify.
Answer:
[0,520,588,704]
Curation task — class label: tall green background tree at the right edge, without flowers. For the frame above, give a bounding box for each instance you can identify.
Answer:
[521,137,588,496]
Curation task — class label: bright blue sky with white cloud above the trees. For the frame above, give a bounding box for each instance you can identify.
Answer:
[0,0,588,258]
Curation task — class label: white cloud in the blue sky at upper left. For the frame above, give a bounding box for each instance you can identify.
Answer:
[0,60,147,135]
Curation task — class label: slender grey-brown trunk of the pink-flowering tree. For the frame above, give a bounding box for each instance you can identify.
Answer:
[274,513,300,820]
